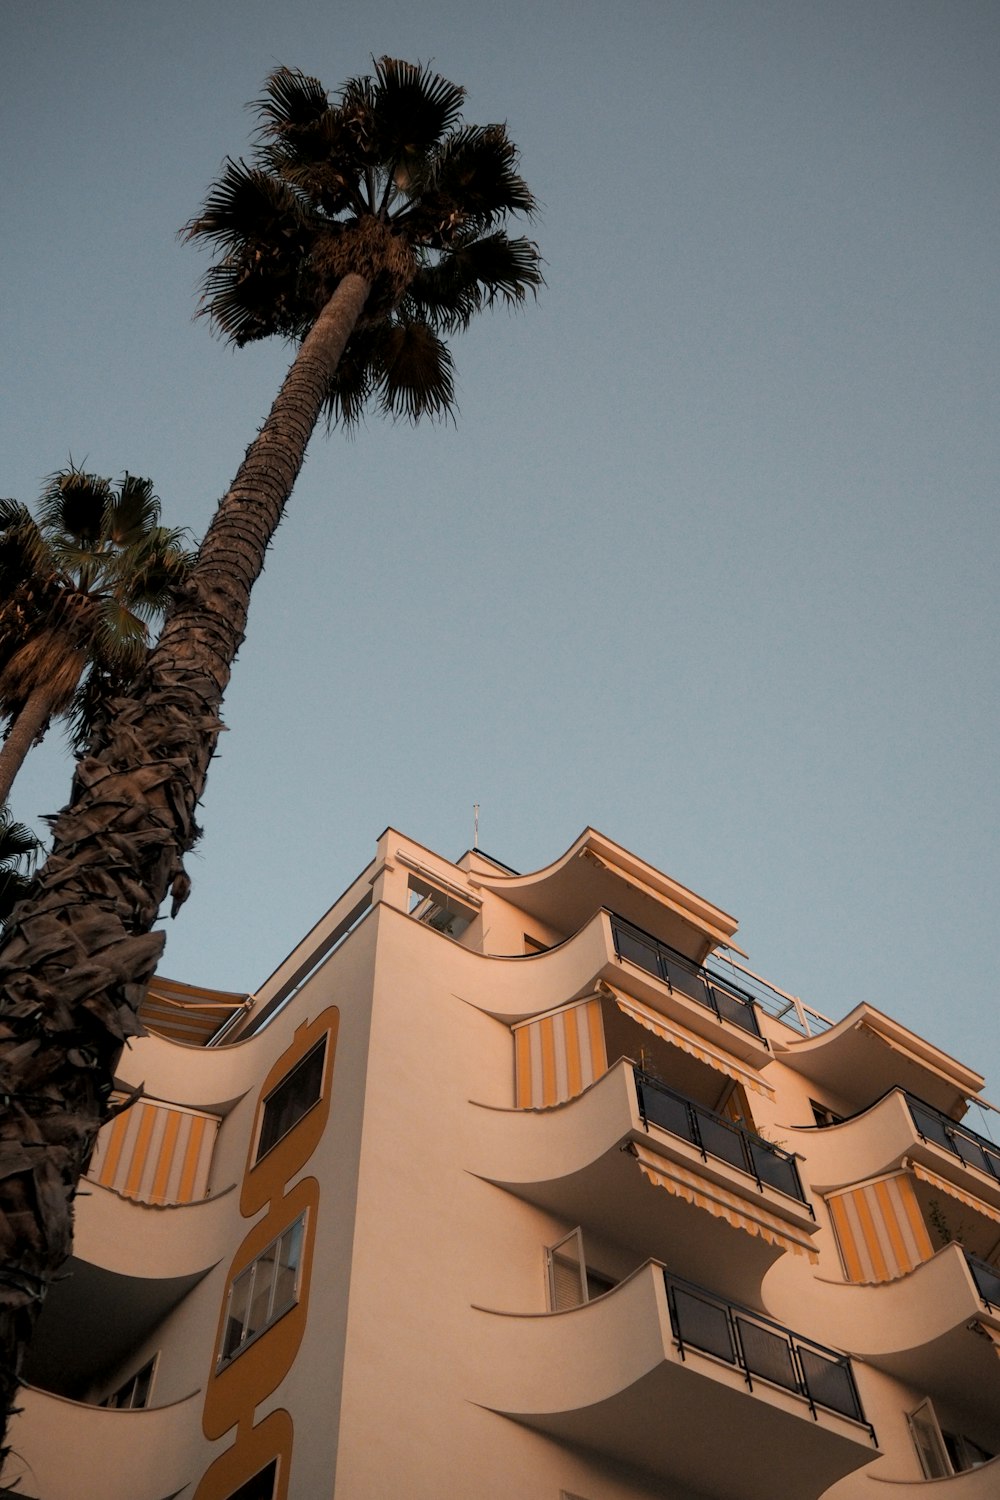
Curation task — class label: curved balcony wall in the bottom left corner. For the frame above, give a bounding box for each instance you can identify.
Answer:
[3,1386,201,1500]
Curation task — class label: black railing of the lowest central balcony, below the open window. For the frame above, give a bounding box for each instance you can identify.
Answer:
[664,1272,876,1443]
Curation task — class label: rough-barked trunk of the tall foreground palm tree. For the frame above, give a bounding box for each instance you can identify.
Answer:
[0,275,370,1457]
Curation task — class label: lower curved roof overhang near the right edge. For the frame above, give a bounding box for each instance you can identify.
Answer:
[774,1004,984,1119]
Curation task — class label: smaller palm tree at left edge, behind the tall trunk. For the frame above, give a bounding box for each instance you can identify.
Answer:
[0,467,192,804]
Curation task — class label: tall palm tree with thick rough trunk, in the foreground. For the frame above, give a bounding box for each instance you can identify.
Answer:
[0,59,541,1440]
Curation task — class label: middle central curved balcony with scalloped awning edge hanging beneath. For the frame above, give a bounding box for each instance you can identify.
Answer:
[466,1059,816,1302]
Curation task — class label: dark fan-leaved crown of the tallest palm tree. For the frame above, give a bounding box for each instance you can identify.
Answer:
[184,57,541,425]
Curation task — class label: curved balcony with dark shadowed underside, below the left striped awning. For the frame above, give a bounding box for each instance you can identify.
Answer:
[27,1185,238,1392]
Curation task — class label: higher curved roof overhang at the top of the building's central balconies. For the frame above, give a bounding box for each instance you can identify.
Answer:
[469,828,739,963]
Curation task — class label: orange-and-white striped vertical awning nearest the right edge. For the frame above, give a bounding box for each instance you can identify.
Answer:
[826,1172,934,1283]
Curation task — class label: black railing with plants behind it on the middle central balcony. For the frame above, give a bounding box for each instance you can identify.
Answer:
[634,1068,813,1214]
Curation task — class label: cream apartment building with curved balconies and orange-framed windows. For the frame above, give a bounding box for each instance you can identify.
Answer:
[4,828,1000,1500]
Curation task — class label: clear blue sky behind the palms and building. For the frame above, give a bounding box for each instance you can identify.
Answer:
[0,0,1000,1103]
